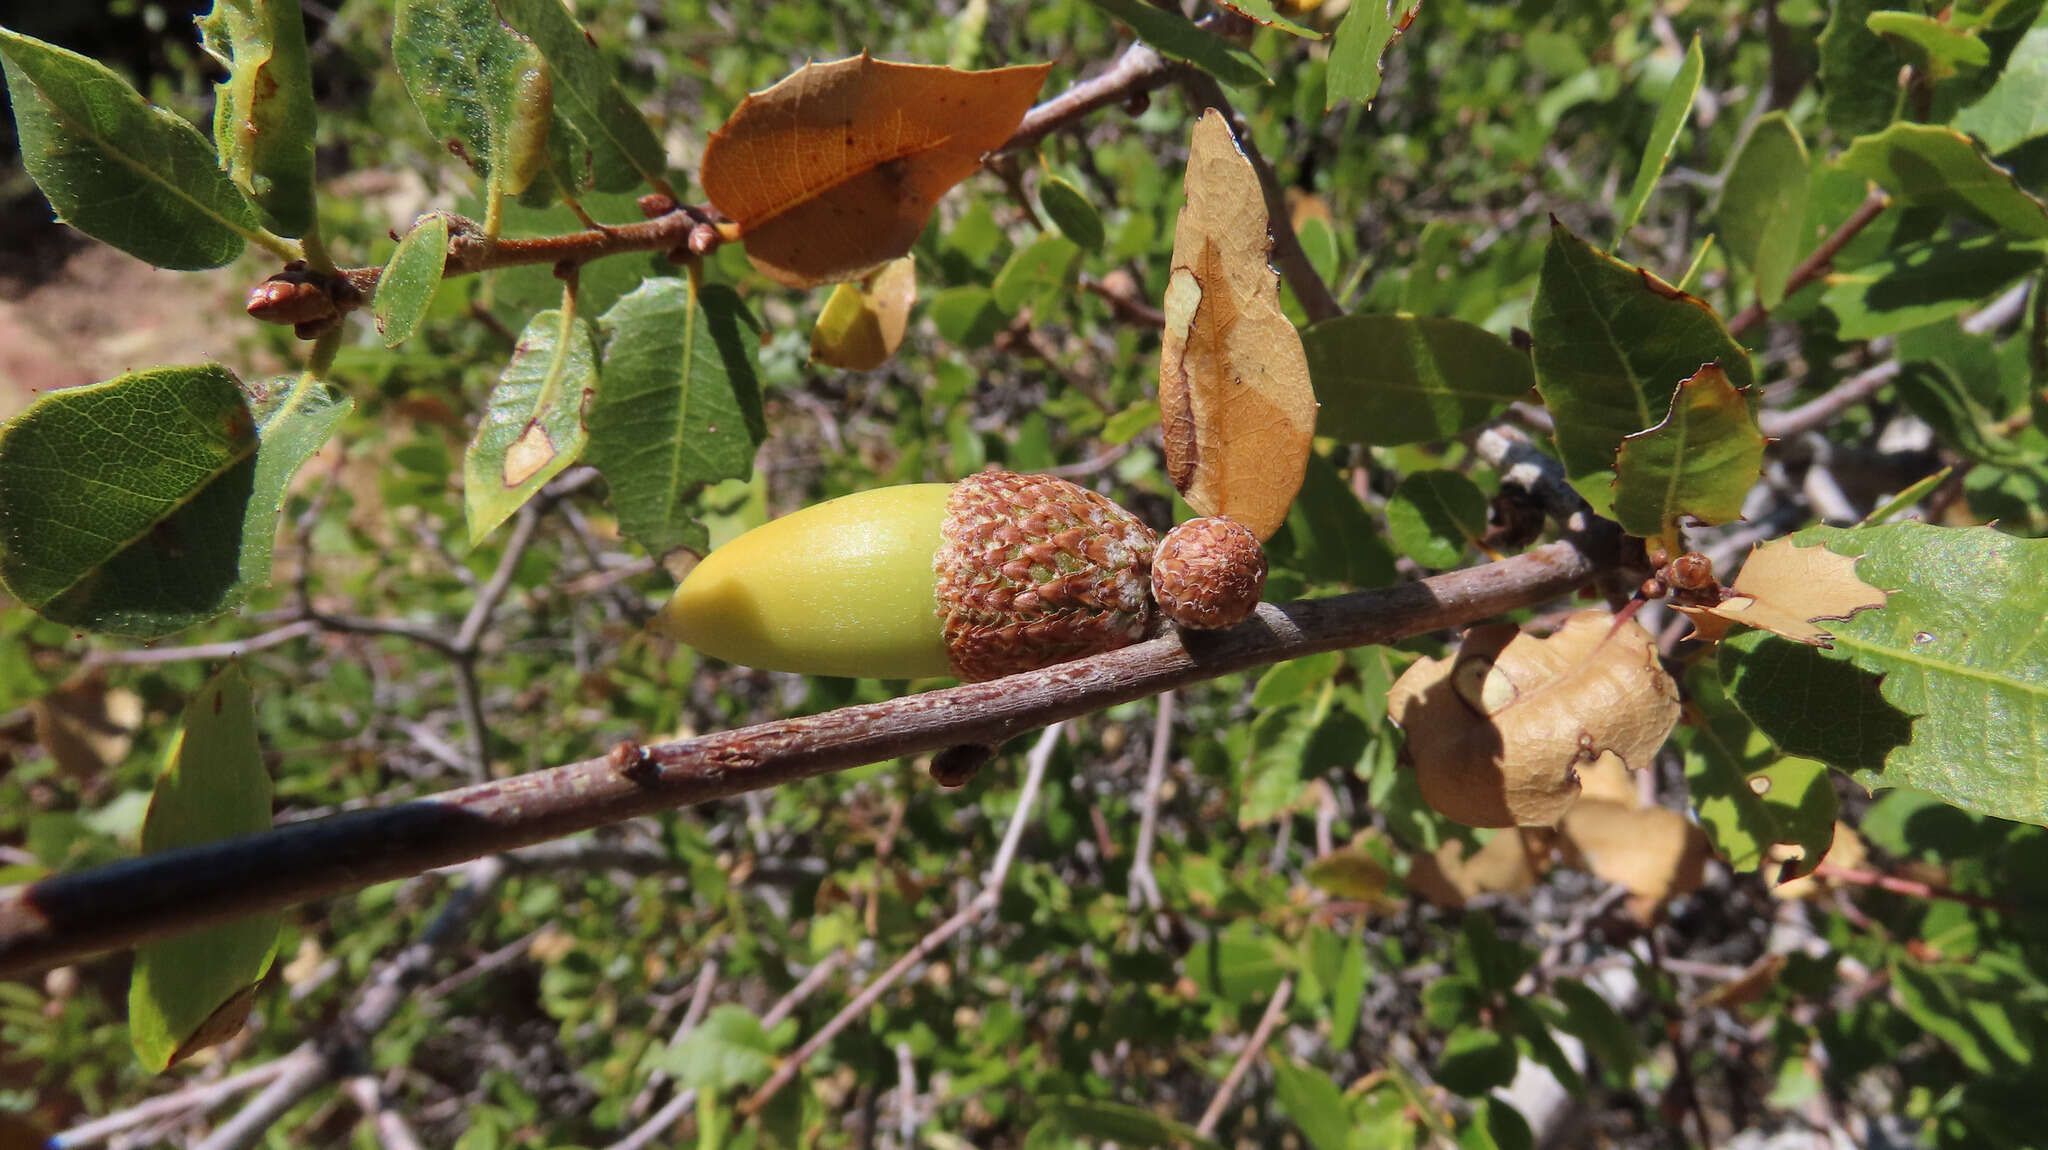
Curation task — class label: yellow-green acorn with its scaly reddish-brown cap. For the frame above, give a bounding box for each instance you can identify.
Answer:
[655,471,1155,681]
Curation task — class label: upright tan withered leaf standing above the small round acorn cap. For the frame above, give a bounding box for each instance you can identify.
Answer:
[1159,108,1315,540]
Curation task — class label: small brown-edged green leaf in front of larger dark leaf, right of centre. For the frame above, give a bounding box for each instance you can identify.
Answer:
[1614,366,1763,540]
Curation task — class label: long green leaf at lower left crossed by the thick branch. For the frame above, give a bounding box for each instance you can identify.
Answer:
[129,663,285,1074]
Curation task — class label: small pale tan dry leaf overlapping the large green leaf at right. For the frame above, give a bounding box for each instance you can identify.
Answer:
[1679,538,1886,647]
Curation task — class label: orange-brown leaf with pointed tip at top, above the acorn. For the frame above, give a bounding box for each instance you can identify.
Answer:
[700,53,1051,286]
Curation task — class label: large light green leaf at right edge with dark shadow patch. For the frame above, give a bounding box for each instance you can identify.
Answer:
[1722,524,2048,823]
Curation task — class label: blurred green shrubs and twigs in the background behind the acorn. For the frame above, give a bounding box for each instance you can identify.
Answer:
[0,0,2048,1150]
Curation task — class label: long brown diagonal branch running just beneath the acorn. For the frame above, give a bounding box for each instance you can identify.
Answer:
[0,534,1618,976]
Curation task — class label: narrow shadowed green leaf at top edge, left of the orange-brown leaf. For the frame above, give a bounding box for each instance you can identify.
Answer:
[498,0,668,192]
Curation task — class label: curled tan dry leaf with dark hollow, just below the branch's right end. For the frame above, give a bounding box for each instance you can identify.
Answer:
[1386,610,1679,827]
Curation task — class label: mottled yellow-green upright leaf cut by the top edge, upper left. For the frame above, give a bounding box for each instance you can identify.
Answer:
[199,0,313,235]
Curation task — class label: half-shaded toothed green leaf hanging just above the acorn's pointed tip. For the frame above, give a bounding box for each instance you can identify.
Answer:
[586,276,766,555]
